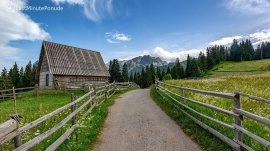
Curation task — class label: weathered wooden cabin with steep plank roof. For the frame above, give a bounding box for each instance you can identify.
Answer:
[36,41,110,87]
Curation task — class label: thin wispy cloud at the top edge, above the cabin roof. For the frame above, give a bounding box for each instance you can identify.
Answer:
[52,0,113,22]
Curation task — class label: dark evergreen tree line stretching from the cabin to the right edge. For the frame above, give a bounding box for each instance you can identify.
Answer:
[109,39,270,88]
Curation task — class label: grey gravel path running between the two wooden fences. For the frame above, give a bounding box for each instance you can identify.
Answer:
[94,89,201,151]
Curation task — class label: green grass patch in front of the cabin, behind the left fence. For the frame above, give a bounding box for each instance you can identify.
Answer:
[0,89,84,126]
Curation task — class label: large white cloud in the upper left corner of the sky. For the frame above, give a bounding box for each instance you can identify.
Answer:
[0,0,50,68]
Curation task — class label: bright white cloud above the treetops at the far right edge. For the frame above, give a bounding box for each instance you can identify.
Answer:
[209,29,270,46]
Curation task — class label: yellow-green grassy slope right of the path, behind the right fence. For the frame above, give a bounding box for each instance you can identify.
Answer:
[152,59,270,150]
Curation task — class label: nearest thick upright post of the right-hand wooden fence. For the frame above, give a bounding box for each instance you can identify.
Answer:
[233,92,243,149]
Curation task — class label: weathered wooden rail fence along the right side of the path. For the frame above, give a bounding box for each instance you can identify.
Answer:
[155,80,270,151]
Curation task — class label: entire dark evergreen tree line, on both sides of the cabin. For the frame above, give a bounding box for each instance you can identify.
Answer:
[0,39,270,89]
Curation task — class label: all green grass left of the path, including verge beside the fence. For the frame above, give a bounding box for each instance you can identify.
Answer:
[0,89,136,151]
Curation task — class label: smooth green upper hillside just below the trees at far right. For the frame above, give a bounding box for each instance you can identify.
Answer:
[209,59,270,77]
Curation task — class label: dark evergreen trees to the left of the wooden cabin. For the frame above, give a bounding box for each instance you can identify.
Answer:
[0,61,38,90]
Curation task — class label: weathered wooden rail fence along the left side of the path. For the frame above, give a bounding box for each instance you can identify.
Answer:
[0,83,136,151]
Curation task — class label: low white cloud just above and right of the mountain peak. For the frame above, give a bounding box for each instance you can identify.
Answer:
[149,47,204,62]
